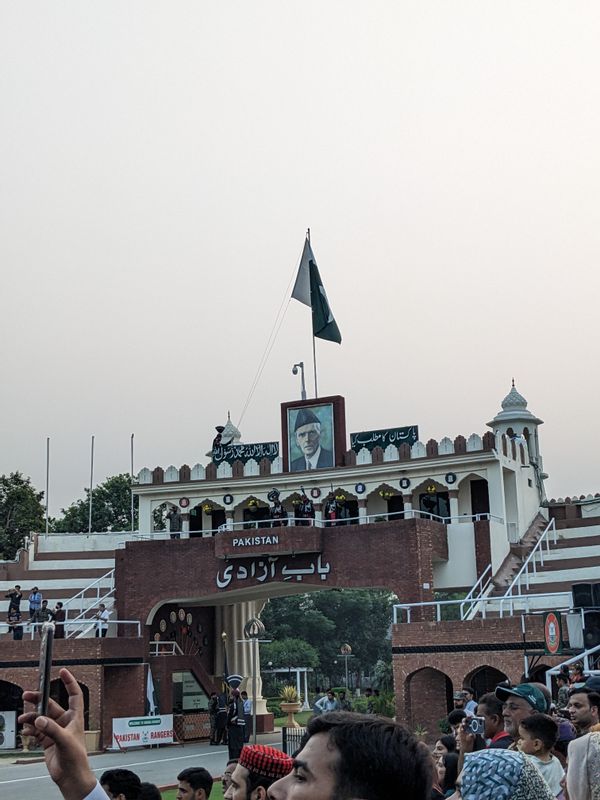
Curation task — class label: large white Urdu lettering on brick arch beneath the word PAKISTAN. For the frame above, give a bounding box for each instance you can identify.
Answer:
[216,554,331,589]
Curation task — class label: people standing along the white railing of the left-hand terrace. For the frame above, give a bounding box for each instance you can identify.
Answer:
[5,584,110,641]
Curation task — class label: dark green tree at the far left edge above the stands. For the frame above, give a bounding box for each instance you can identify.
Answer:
[0,472,45,559]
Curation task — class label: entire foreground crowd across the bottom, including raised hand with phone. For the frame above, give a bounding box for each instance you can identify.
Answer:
[14,669,600,800]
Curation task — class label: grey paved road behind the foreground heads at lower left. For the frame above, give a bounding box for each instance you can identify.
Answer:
[0,733,281,800]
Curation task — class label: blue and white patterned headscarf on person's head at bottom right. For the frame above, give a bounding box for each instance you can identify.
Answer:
[452,750,552,800]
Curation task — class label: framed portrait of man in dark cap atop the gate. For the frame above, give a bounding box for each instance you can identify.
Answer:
[282,397,346,472]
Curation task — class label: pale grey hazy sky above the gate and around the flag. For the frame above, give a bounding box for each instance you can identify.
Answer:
[0,0,600,513]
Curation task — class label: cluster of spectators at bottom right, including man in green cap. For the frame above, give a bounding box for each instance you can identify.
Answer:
[431,664,600,800]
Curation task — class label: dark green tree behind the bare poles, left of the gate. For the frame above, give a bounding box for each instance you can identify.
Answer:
[54,473,138,533]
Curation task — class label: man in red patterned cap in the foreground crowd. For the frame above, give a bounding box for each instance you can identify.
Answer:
[224,744,294,800]
